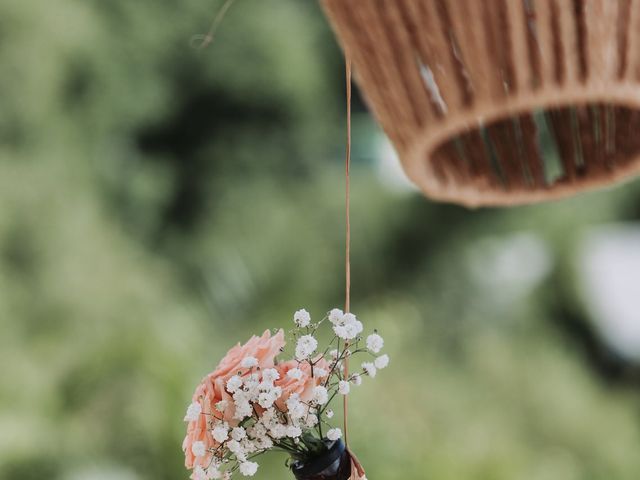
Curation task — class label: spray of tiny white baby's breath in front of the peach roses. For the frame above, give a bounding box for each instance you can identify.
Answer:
[184,308,389,480]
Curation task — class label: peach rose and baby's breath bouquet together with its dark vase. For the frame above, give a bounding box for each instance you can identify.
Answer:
[182,309,389,480]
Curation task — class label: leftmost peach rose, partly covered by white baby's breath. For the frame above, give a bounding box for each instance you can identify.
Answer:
[182,330,285,469]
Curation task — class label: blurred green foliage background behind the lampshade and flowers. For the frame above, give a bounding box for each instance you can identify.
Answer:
[0,0,640,480]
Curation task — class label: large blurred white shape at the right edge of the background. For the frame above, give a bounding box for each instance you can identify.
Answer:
[579,225,640,360]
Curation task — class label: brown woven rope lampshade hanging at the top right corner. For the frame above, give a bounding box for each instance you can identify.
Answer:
[322,0,640,206]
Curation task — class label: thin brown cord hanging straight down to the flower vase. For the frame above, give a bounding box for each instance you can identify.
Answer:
[342,56,351,446]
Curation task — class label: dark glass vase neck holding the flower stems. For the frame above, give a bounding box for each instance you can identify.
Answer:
[291,440,351,480]
